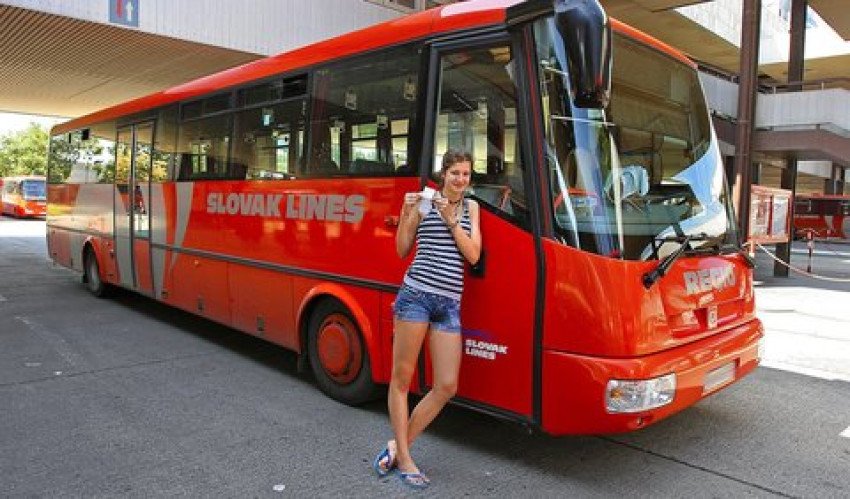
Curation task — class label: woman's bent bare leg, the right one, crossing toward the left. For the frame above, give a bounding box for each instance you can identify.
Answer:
[399,330,463,452]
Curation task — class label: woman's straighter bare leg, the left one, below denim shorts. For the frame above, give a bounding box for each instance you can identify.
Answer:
[387,319,428,472]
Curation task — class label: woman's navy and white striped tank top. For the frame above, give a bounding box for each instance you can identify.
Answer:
[404,199,472,300]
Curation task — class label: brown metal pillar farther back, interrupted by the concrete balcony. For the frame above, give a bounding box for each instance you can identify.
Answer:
[773,0,808,277]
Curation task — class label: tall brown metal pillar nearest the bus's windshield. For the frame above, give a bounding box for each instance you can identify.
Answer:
[733,0,761,239]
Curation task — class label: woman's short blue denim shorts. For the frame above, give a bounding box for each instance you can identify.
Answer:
[393,286,460,334]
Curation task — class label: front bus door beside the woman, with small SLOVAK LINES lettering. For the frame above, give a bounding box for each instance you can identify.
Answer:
[420,38,537,418]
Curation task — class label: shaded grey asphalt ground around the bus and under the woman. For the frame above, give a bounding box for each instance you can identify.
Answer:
[0,218,850,498]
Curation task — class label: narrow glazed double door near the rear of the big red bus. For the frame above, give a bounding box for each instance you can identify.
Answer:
[114,122,154,295]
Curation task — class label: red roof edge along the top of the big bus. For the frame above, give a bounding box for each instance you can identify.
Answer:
[51,0,694,135]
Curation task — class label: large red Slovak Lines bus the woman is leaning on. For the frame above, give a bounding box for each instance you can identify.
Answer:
[47,0,763,434]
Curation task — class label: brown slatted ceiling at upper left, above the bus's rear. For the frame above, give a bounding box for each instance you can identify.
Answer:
[0,5,261,117]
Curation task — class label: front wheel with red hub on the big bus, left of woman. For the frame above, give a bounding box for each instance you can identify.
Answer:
[307,300,377,405]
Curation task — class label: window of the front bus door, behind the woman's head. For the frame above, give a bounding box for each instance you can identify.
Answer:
[432,45,529,226]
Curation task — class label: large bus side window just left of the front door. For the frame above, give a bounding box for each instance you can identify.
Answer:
[305,47,419,176]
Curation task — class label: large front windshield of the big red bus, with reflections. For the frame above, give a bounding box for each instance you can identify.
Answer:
[535,18,737,260]
